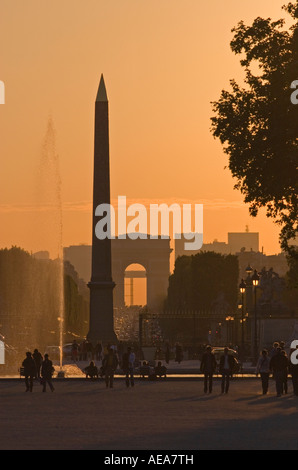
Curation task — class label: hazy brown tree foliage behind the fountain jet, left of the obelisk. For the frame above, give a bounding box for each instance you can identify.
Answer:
[0,247,88,348]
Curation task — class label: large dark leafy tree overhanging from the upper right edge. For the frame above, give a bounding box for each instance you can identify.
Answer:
[211,1,298,258]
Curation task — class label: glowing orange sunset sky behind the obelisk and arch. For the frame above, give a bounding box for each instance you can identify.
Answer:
[0,0,286,254]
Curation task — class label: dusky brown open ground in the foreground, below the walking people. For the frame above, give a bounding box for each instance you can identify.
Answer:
[0,378,298,450]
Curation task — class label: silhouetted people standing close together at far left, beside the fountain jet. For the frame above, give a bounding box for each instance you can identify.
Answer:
[22,349,55,392]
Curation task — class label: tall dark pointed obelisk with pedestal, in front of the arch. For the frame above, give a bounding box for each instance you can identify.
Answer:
[88,75,117,346]
